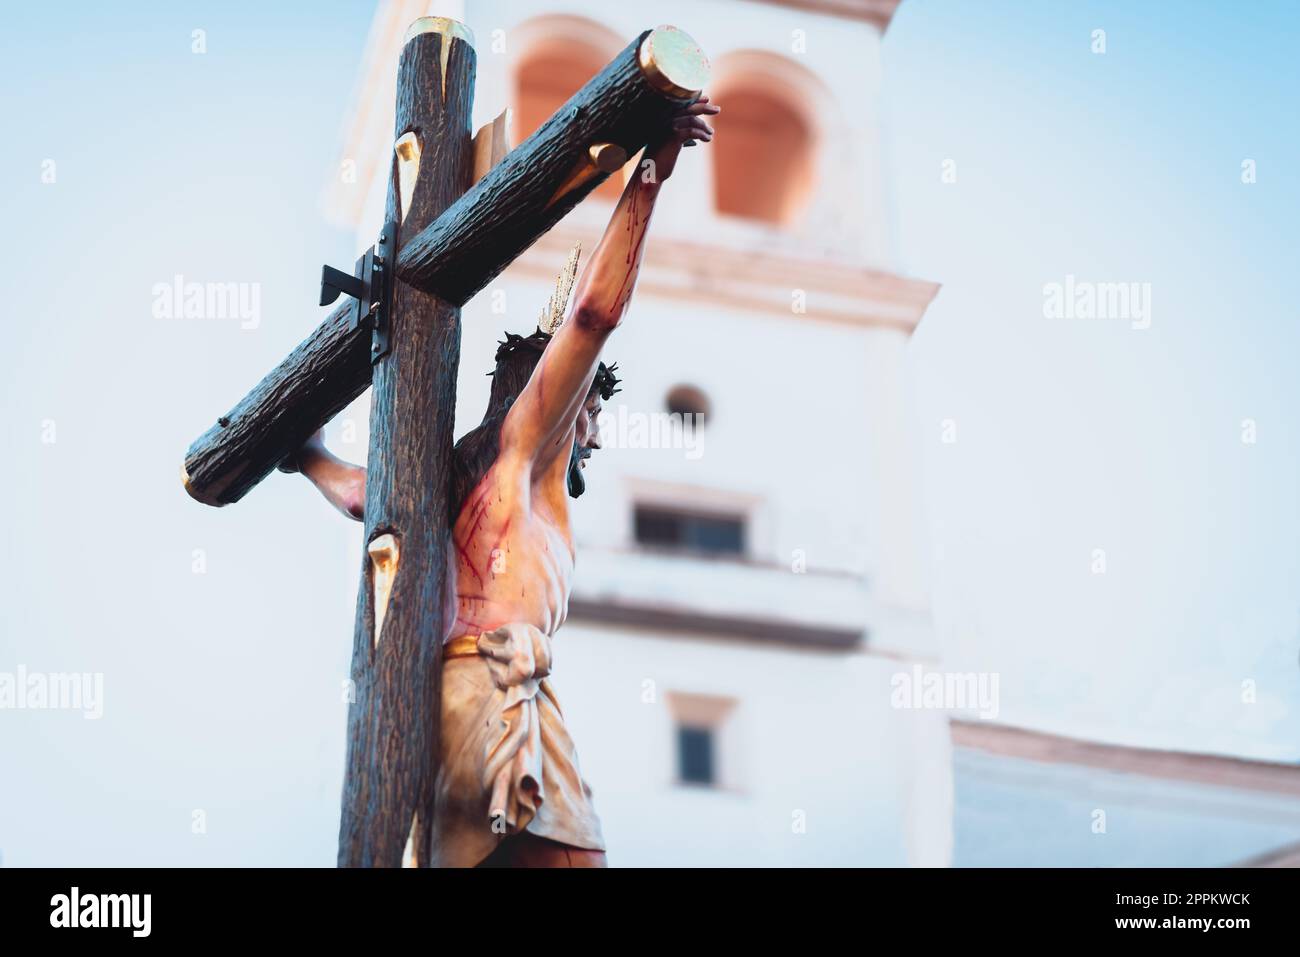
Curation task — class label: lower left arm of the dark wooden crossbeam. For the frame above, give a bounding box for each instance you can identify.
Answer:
[185,299,371,506]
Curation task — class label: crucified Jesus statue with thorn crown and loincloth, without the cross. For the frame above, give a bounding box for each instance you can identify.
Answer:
[286,96,719,867]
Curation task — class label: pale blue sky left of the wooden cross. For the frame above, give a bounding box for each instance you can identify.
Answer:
[0,3,373,865]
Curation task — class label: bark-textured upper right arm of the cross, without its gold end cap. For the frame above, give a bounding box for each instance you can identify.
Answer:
[398,31,688,304]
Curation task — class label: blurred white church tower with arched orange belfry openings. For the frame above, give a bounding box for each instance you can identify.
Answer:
[329,0,952,866]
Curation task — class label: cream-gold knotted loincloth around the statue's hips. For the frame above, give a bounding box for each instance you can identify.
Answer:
[430,624,605,867]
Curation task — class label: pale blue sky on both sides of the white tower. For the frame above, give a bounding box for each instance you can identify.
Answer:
[0,0,1300,865]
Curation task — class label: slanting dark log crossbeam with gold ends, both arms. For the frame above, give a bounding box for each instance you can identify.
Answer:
[182,18,709,506]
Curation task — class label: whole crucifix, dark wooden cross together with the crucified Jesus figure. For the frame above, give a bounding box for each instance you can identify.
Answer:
[182,17,718,866]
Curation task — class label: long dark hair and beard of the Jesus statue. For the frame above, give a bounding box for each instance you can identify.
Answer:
[450,329,620,514]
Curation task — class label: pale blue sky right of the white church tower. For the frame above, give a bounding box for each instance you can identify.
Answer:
[884,0,1300,759]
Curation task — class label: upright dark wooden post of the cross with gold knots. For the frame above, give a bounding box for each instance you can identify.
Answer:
[338,17,476,867]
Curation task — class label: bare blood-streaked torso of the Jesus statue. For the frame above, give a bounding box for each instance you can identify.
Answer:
[447,430,575,641]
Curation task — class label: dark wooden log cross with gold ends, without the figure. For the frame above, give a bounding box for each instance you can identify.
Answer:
[182,17,709,866]
